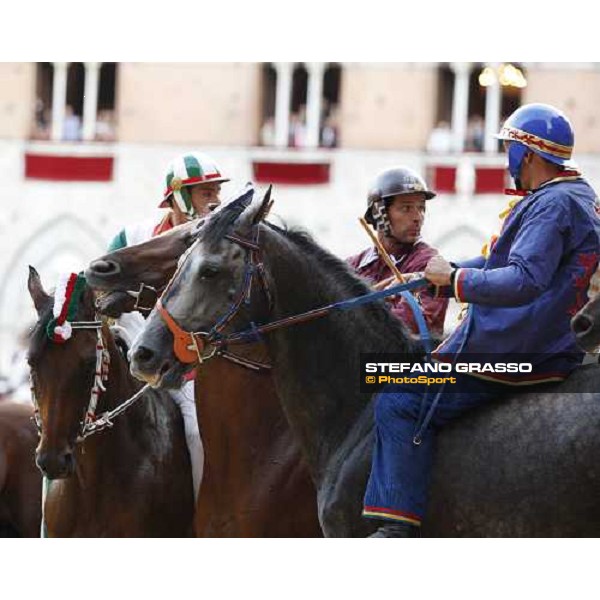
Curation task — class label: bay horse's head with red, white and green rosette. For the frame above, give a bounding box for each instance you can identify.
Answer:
[28,267,102,479]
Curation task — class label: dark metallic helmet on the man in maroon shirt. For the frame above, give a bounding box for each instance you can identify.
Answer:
[365,167,436,235]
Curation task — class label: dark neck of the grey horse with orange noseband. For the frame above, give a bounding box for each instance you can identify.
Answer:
[263,231,413,480]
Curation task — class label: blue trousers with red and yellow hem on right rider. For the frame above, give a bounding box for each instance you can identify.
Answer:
[363,375,508,526]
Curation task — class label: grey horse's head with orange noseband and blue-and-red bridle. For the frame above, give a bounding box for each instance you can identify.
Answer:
[131,185,271,387]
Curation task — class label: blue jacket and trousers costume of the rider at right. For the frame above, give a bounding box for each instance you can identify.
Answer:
[363,103,600,525]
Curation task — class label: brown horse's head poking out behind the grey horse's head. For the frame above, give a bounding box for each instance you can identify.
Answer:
[85,219,204,317]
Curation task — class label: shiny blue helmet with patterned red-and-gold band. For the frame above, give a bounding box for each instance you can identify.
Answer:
[496,104,575,181]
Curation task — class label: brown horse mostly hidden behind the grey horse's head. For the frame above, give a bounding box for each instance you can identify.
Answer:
[86,210,322,537]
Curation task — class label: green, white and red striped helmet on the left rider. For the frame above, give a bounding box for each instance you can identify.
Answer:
[160,152,229,217]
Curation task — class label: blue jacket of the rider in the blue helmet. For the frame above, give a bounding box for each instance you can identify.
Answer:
[434,176,600,385]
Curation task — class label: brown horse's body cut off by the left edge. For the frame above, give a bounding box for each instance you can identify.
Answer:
[0,400,42,537]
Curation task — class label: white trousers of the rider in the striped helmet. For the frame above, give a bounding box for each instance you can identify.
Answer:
[112,312,204,500]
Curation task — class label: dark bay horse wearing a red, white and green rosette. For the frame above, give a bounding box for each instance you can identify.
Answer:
[28,268,194,537]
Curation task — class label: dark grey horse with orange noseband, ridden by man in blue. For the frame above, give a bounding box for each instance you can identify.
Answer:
[132,188,600,537]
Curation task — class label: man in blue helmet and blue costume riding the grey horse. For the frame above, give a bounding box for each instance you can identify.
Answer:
[363,104,600,537]
